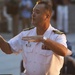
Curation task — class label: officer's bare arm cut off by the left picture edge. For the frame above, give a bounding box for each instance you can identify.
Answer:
[0,35,13,54]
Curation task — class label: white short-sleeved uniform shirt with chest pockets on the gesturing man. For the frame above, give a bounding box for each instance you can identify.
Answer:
[9,25,66,75]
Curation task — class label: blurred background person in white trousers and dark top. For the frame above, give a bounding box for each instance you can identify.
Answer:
[56,0,70,33]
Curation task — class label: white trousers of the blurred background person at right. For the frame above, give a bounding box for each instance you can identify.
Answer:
[57,5,68,33]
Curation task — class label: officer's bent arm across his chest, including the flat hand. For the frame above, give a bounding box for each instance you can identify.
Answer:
[22,36,72,56]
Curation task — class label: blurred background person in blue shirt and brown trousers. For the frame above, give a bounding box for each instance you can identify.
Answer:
[20,0,33,29]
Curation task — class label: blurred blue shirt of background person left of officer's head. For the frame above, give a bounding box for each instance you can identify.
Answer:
[20,0,33,18]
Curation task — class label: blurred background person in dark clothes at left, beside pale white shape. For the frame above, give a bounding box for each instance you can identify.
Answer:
[4,0,20,36]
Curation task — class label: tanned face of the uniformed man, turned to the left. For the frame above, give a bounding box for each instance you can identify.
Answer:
[32,4,46,27]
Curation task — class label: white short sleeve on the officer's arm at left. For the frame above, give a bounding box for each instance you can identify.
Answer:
[8,33,23,53]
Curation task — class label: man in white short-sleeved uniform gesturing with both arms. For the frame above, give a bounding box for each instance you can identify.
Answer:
[0,1,71,75]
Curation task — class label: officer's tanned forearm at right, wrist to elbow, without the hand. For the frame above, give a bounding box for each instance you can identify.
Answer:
[42,39,72,56]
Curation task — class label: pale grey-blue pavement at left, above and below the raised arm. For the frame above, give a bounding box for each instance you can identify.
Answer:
[0,33,22,75]
